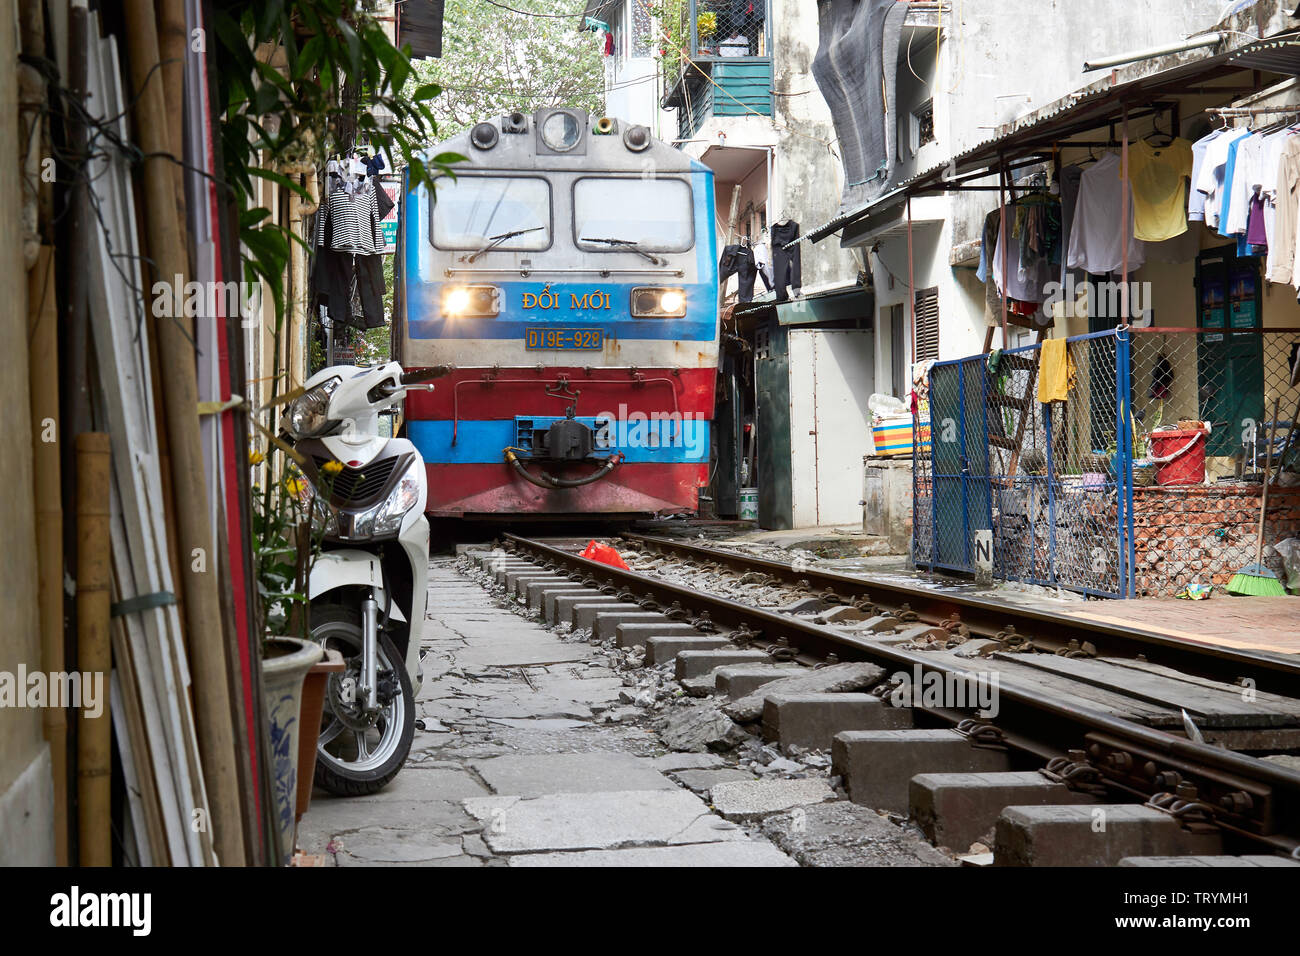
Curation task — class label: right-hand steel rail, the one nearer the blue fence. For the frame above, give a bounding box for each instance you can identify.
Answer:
[623,533,1300,700]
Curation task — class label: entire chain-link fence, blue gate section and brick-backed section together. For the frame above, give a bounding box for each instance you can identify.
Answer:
[913,329,1300,597]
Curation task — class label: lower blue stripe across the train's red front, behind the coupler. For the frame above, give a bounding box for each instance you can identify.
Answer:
[407,418,709,464]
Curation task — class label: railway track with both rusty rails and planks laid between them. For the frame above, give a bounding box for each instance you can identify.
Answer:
[475,535,1300,858]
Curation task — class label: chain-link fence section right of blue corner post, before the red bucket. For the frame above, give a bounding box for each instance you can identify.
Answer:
[1131,329,1300,594]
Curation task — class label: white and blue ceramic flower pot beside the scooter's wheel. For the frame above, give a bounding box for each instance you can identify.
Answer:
[261,637,322,866]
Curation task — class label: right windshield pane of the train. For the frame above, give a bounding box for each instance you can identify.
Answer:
[573,177,694,252]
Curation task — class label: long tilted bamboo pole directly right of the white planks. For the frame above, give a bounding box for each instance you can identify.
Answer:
[125,0,246,866]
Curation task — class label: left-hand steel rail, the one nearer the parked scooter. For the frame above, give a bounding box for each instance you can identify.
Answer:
[503,535,1300,852]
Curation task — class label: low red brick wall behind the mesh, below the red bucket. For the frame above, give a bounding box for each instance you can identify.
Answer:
[1134,485,1300,596]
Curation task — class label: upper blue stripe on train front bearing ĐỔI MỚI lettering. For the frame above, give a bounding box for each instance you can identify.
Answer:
[407,280,718,342]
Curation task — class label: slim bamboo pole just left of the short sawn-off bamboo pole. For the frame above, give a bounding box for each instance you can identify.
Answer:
[27,246,69,866]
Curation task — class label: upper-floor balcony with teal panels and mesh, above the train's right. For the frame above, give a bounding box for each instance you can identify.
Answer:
[663,0,772,139]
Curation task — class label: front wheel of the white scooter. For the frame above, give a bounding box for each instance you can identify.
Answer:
[311,605,415,796]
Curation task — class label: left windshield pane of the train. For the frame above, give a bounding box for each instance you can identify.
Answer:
[430,176,551,251]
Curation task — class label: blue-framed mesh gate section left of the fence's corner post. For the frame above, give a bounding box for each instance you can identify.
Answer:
[913,330,1134,597]
